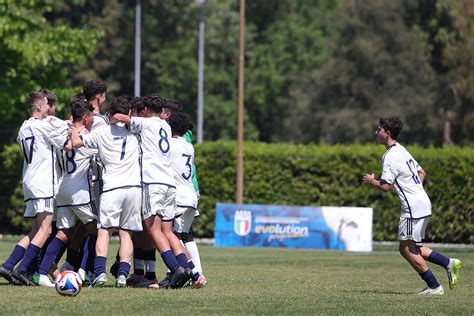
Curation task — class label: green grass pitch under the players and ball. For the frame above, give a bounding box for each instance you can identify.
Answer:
[0,240,474,315]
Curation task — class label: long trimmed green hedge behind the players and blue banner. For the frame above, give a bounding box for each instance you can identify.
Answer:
[0,142,474,243]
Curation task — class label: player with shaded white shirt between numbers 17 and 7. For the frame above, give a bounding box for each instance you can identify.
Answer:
[38,98,97,287]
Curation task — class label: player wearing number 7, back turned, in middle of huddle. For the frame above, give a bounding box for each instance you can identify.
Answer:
[71,97,143,287]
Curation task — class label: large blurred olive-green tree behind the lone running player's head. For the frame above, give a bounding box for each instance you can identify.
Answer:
[289,0,436,144]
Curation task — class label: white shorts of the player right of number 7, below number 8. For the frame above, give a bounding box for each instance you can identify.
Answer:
[142,184,176,221]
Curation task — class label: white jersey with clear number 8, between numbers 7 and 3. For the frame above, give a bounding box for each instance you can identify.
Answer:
[130,117,175,188]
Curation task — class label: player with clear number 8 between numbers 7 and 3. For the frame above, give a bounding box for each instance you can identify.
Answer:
[111,95,191,288]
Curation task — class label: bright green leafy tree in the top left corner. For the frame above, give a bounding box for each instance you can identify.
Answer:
[0,0,101,136]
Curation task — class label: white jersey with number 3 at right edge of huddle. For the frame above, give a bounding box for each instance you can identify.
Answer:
[171,137,198,209]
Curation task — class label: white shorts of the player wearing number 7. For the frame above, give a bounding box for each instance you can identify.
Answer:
[97,187,143,231]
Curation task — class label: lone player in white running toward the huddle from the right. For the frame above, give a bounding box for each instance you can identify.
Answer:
[363,117,461,295]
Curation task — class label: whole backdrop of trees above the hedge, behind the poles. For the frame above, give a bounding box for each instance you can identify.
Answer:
[0,0,474,146]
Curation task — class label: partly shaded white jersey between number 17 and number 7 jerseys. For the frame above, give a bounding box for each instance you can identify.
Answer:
[56,128,97,207]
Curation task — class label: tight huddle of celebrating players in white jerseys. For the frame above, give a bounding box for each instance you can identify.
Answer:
[0,80,207,289]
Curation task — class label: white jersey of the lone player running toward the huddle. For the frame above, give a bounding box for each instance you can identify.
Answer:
[380,143,431,219]
